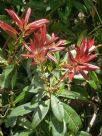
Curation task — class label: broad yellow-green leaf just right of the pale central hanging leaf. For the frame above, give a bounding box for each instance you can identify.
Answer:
[63,103,82,134]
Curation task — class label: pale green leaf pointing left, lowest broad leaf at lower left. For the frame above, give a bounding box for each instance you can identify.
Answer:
[9,102,38,117]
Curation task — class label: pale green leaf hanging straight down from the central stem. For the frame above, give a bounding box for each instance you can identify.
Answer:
[51,95,64,122]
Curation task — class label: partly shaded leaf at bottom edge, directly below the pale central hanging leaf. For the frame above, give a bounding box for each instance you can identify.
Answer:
[50,117,67,136]
